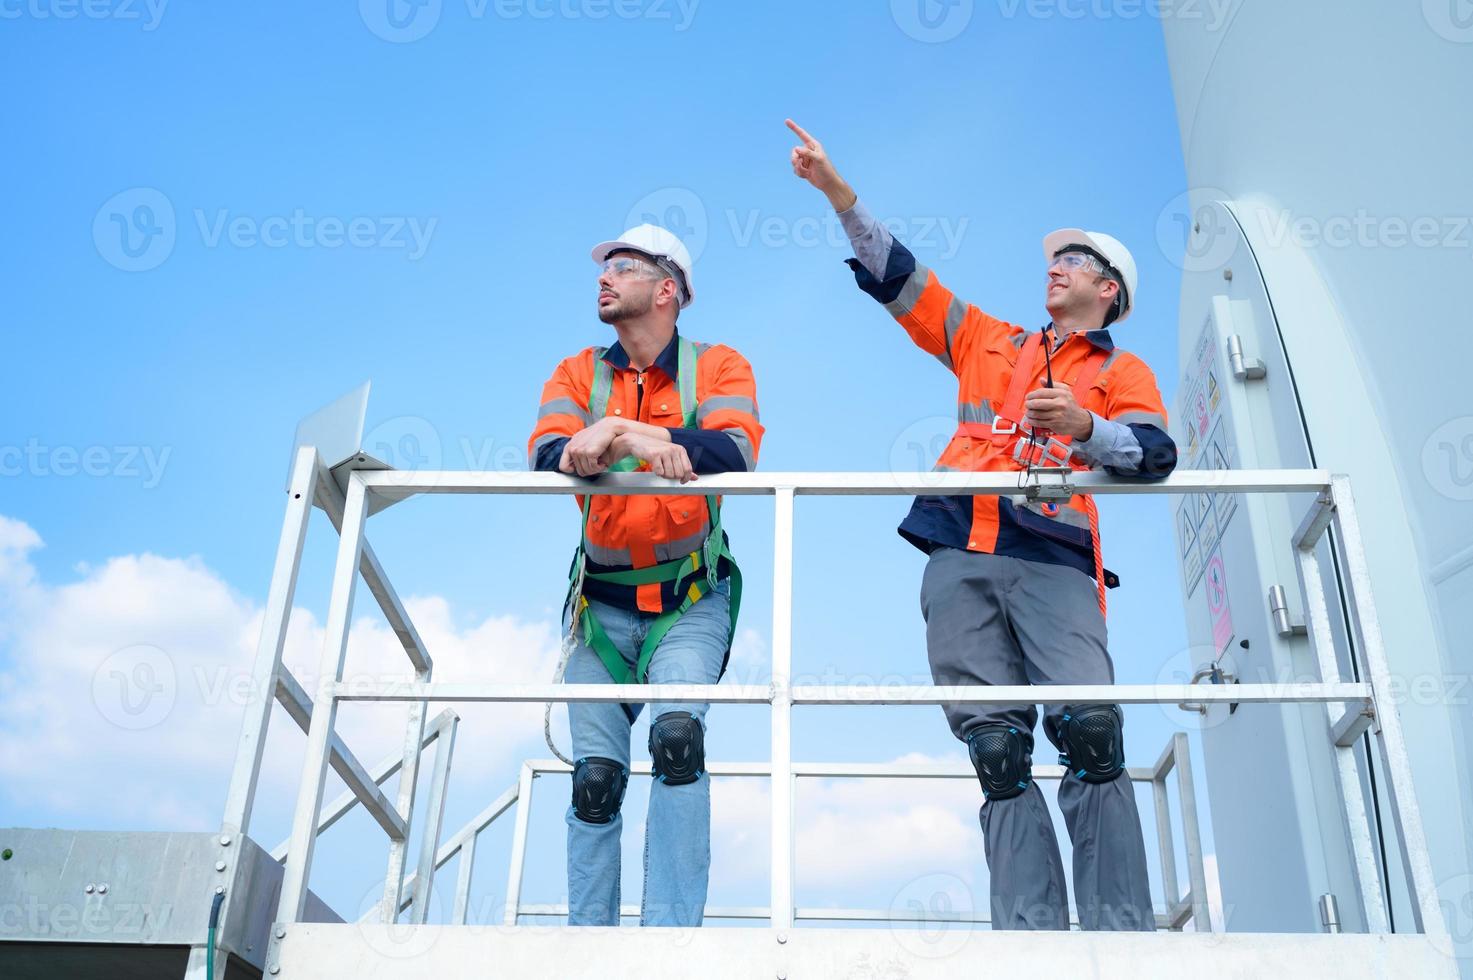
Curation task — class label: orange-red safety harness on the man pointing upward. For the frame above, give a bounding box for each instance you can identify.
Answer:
[957,330,1109,616]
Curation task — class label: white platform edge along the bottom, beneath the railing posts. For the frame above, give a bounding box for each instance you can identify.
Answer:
[271,923,1457,980]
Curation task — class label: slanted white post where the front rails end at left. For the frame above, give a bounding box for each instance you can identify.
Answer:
[277,473,368,923]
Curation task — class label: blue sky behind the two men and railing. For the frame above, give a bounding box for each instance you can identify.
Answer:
[0,0,1213,931]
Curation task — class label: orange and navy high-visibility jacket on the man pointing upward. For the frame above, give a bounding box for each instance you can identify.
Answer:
[850,242,1177,578]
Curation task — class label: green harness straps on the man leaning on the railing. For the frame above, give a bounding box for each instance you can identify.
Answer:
[569,337,741,684]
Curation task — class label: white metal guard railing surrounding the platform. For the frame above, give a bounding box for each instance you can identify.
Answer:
[225,447,1444,934]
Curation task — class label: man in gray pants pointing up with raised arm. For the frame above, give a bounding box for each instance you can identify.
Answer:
[788,119,1177,930]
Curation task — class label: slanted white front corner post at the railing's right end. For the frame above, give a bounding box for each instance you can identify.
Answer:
[1330,476,1446,936]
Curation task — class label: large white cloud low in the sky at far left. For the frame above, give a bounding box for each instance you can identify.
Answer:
[0,517,557,846]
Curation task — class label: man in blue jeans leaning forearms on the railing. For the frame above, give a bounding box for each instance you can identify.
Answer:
[527,224,763,925]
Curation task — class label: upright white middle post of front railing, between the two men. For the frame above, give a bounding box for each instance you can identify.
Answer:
[772,486,794,928]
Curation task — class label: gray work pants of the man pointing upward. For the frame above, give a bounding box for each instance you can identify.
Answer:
[921,548,1155,931]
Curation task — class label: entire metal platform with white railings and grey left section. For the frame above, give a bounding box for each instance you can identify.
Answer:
[0,445,1455,980]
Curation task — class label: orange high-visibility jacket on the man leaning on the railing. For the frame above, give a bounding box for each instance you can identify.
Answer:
[527,336,763,613]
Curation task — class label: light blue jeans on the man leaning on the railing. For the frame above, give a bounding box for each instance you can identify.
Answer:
[563,581,731,925]
